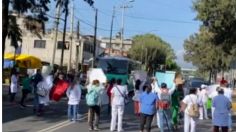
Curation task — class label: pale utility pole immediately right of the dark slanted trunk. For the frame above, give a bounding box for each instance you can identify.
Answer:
[67,1,74,71]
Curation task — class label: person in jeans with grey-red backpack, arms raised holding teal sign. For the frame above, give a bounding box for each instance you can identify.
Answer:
[156,83,176,132]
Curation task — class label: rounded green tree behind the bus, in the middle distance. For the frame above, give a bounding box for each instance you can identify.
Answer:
[129,34,175,71]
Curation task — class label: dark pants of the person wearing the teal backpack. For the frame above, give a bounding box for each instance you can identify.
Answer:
[88,105,100,128]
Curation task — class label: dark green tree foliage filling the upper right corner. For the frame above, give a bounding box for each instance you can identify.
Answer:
[193,0,236,54]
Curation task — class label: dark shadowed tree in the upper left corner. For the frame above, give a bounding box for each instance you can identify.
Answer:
[2,0,50,65]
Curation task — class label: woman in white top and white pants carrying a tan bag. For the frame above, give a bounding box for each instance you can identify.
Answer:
[181,88,198,132]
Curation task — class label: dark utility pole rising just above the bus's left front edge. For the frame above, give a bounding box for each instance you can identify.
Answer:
[92,9,98,68]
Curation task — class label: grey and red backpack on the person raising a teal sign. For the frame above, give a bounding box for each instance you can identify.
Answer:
[158,89,171,110]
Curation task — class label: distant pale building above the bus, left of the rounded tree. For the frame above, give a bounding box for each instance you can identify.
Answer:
[101,35,133,56]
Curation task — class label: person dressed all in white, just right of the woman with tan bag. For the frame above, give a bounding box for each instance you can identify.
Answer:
[198,84,208,120]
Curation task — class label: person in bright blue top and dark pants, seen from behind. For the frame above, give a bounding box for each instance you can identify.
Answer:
[139,85,159,132]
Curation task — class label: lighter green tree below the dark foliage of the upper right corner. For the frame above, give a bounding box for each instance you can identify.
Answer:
[184,27,232,80]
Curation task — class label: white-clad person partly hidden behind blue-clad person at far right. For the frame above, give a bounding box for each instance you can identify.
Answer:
[220,81,233,131]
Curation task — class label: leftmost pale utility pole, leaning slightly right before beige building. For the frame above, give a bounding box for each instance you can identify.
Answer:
[51,4,61,68]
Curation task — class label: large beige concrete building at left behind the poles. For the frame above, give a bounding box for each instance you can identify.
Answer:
[5,14,104,68]
